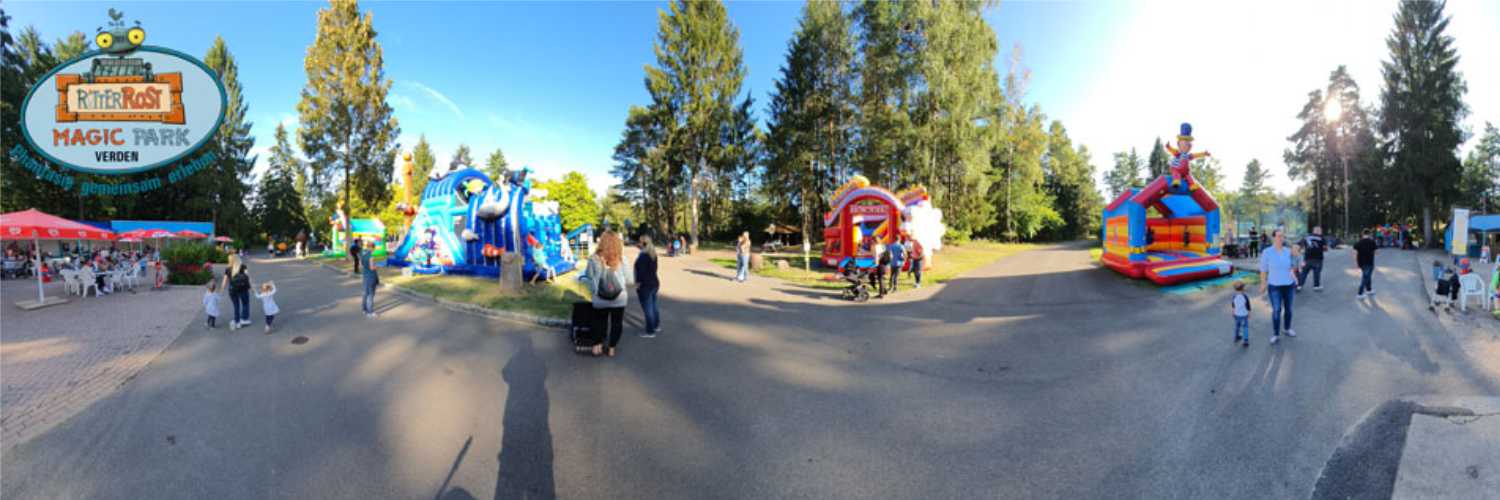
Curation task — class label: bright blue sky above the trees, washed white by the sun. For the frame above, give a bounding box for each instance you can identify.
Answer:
[3,0,1500,192]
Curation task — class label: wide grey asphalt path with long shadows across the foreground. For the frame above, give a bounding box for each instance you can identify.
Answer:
[0,246,1500,498]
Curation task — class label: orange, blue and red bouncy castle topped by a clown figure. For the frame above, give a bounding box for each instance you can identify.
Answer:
[1100,123,1235,285]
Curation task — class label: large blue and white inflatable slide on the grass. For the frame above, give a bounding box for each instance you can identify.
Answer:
[387,168,576,279]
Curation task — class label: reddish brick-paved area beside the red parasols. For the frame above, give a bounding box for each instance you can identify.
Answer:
[0,279,203,449]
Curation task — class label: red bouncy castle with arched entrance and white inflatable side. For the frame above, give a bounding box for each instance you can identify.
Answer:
[824,176,948,267]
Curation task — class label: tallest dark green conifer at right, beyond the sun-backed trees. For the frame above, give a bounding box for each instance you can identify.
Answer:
[1379,0,1469,245]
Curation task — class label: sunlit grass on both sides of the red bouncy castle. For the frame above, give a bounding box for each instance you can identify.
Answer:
[710,240,1037,290]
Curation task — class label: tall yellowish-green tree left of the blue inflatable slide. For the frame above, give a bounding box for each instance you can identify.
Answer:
[297,0,401,216]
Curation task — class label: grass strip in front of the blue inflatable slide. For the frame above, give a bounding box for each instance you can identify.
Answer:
[318,257,588,320]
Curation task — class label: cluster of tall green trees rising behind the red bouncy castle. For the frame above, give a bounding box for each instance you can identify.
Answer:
[612,0,1101,242]
